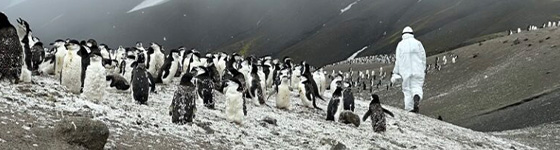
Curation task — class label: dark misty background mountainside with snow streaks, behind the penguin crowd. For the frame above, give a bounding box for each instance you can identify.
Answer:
[4,0,560,66]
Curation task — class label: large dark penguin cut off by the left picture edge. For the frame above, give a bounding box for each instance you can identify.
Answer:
[0,12,23,84]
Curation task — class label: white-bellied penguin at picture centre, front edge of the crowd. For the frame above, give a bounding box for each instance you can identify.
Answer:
[276,70,292,110]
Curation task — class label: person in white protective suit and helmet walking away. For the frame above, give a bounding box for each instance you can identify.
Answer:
[391,26,426,113]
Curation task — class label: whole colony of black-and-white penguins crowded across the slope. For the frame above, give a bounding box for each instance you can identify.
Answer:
[5,13,560,132]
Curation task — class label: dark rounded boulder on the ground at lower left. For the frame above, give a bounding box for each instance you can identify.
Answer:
[54,118,109,150]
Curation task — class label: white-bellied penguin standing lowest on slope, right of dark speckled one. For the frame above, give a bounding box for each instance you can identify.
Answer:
[224,78,247,124]
